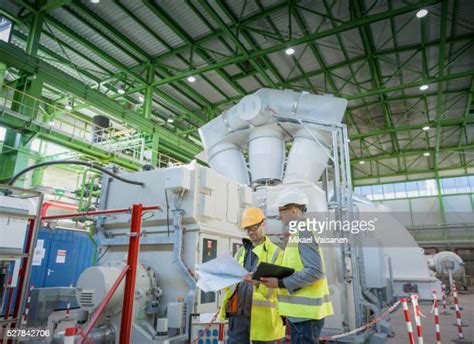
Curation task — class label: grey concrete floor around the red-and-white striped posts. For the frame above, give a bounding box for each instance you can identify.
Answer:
[388,290,474,344]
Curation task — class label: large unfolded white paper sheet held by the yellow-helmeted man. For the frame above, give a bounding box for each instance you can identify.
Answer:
[196,253,248,293]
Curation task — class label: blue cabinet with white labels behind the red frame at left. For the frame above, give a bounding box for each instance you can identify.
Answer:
[30,228,96,288]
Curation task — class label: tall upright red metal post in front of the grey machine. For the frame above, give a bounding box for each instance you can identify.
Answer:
[119,204,143,344]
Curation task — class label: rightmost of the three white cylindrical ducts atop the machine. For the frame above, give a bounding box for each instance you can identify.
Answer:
[284,129,329,183]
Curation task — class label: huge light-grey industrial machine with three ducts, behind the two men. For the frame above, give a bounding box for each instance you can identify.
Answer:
[39,89,440,343]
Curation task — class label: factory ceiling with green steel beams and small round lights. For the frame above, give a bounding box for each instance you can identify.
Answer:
[0,0,474,184]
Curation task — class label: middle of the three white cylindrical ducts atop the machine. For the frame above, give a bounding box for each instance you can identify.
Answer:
[249,128,285,183]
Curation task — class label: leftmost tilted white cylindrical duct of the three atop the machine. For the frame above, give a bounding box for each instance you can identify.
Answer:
[208,143,249,184]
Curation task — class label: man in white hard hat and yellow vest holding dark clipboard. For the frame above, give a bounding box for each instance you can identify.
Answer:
[261,188,334,344]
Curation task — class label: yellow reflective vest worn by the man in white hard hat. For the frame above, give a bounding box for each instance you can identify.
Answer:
[278,234,334,319]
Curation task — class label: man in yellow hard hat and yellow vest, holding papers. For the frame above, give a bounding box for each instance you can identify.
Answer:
[219,208,284,344]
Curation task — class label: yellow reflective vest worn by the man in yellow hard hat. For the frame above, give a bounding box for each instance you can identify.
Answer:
[218,236,285,341]
